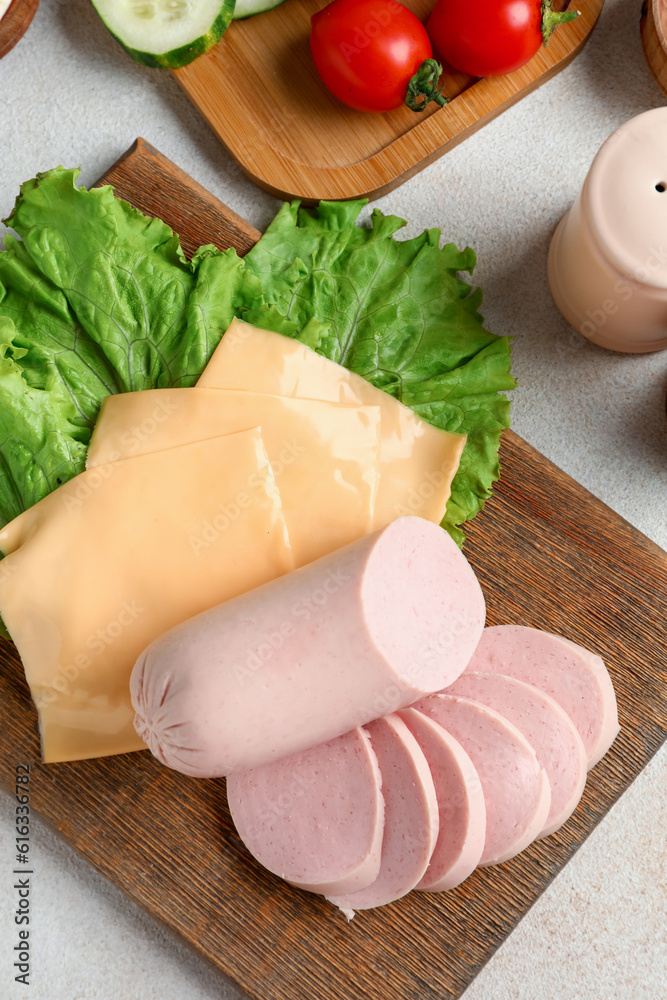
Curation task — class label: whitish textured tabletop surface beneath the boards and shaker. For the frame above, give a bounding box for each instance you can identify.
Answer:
[0,0,667,1000]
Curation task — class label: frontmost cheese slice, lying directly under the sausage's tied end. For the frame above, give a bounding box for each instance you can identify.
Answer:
[0,428,294,762]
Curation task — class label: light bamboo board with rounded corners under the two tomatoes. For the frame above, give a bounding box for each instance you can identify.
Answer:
[174,0,604,202]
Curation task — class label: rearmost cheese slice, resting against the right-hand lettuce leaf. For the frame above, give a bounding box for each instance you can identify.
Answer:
[197,320,466,528]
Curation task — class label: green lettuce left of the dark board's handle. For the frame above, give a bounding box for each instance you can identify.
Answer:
[0,167,274,524]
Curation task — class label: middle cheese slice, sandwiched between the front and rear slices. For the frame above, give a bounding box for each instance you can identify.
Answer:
[88,389,380,566]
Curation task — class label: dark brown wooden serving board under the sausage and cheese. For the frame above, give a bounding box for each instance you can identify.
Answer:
[0,141,667,1000]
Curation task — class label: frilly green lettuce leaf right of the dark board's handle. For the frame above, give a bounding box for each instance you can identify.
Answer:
[245,201,515,544]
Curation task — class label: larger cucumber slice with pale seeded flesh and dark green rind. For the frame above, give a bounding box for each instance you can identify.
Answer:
[92,0,234,69]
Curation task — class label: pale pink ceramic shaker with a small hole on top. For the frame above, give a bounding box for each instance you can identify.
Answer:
[548,108,667,353]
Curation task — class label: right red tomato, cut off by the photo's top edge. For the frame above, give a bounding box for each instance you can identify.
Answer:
[426,0,577,76]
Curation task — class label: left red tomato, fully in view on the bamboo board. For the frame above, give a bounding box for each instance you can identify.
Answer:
[310,0,432,111]
